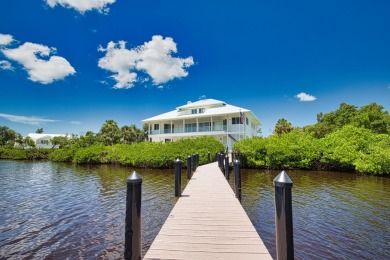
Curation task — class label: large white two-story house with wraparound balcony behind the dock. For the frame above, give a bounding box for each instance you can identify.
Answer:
[142,99,260,148]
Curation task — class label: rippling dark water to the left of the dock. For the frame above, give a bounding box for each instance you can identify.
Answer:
[0,161,180,259]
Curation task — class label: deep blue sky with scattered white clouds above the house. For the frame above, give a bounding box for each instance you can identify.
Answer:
[0,0,390,136]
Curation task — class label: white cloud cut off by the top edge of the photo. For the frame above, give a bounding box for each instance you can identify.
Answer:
[46,0,116,13]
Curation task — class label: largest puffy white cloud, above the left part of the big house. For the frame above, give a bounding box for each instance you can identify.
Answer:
[98,35,194,88]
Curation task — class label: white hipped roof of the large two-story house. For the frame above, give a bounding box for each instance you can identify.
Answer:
[142,99,260,124]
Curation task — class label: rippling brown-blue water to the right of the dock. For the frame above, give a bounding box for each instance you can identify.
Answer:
[238,170,390,259]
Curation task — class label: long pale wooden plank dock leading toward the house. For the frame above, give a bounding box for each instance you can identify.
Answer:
[144,162,272,259]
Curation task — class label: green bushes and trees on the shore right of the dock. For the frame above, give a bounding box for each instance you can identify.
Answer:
[234,103,390,174]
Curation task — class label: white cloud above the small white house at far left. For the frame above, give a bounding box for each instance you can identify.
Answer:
[3,42,76,84]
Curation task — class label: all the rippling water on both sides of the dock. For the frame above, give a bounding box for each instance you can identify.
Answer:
[0,161,390,259]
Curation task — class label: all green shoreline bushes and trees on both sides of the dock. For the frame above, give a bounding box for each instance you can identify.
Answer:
[0,103,390,175]
